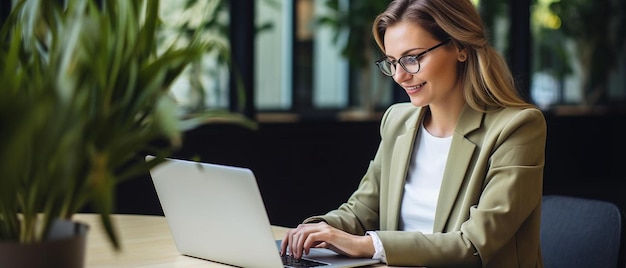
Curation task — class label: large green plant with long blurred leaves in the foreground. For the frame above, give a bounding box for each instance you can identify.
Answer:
[0,0,249,267]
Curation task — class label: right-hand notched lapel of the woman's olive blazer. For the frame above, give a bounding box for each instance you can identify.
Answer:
[433,104,483,233]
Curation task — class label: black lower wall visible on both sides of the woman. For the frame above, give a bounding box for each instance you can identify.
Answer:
[118,114,626,226]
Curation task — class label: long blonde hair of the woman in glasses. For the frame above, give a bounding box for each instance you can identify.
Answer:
[372,0,533,111]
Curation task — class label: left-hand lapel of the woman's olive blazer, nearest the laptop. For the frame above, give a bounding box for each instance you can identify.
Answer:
[386,108,428,230]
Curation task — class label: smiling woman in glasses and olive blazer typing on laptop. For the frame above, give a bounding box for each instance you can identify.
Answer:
[282,0,546,267]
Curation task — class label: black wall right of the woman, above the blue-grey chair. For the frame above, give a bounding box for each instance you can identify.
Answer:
[544,114,626,206]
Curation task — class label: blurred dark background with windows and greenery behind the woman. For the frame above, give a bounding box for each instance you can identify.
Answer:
[0,0,626,226]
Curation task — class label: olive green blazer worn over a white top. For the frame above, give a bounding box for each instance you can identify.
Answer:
[305,103,546,267]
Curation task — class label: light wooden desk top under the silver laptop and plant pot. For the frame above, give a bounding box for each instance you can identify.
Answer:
[74,214,385,268]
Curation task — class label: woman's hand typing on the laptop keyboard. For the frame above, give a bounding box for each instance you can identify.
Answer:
[281,222,374,259]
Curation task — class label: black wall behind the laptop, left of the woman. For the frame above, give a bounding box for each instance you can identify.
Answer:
[117,121,380,226]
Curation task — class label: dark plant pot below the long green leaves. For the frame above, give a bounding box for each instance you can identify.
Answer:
[0,220,89,268]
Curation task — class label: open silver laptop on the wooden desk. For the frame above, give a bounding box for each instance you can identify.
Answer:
[146,156,379,268]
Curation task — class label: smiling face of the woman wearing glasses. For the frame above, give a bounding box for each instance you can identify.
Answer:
[383,22,466,106]
